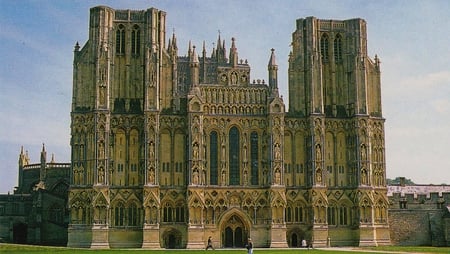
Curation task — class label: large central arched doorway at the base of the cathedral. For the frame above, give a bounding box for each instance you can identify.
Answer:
[222,215,248,248]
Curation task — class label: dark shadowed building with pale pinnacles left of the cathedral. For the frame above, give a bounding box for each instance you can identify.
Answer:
[0,146,70,246]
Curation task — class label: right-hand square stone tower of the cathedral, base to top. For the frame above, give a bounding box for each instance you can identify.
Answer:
[285,17,389,246]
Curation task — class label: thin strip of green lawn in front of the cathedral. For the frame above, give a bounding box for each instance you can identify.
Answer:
[0,243,450,254]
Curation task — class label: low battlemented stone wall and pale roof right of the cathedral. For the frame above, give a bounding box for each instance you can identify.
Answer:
[388,177,450,246]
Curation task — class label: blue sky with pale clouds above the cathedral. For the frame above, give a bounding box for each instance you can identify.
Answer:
[0,0,450,190]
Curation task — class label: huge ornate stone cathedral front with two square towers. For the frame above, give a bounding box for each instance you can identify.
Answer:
[67,6,390,249]
